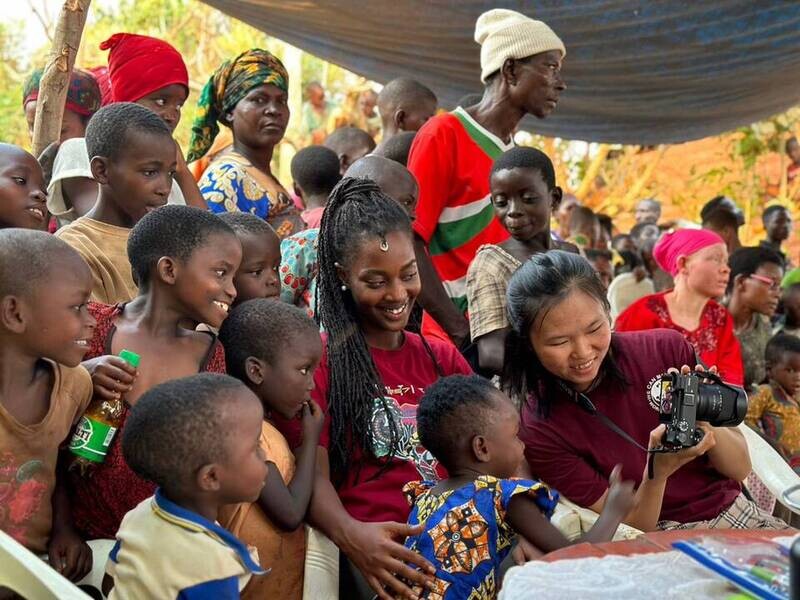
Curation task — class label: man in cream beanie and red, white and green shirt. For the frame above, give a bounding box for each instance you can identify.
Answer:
[408,9,566,349]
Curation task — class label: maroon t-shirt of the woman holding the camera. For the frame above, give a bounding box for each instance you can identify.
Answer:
[519,329,741,523]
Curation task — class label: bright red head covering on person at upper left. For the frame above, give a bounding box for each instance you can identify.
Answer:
[100,33,189,102]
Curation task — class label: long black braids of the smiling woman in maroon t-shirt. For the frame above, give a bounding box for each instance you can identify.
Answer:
[317,177,412,484]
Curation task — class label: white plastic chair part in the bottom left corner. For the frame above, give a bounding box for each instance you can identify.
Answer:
[0,531,91,600]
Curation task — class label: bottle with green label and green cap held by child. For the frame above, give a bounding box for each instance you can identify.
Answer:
[69,350,141,475]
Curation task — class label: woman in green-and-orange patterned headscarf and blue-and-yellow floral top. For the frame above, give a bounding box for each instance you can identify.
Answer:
[187,49,305,239]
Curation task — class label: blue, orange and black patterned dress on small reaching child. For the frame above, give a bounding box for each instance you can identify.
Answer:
[403,475,558,600]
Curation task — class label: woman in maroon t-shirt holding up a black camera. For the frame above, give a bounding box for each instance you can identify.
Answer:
[503,250,786,531]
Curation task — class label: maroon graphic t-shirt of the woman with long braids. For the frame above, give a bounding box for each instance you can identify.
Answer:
[276,332,472,523]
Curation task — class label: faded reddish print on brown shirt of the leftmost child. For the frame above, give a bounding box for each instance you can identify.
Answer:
[0,452,47,546]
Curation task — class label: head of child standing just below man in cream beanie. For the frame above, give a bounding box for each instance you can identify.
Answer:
[489,146,562,242]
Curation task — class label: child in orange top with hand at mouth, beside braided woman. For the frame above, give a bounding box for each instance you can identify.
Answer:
[219,298,323,600]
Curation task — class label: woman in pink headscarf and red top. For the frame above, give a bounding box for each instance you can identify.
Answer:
[616,229,744,385]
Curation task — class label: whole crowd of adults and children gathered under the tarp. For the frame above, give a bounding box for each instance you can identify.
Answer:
[0,9,800,600]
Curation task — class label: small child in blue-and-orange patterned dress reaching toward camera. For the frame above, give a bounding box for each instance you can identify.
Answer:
[404,375,634,598]
